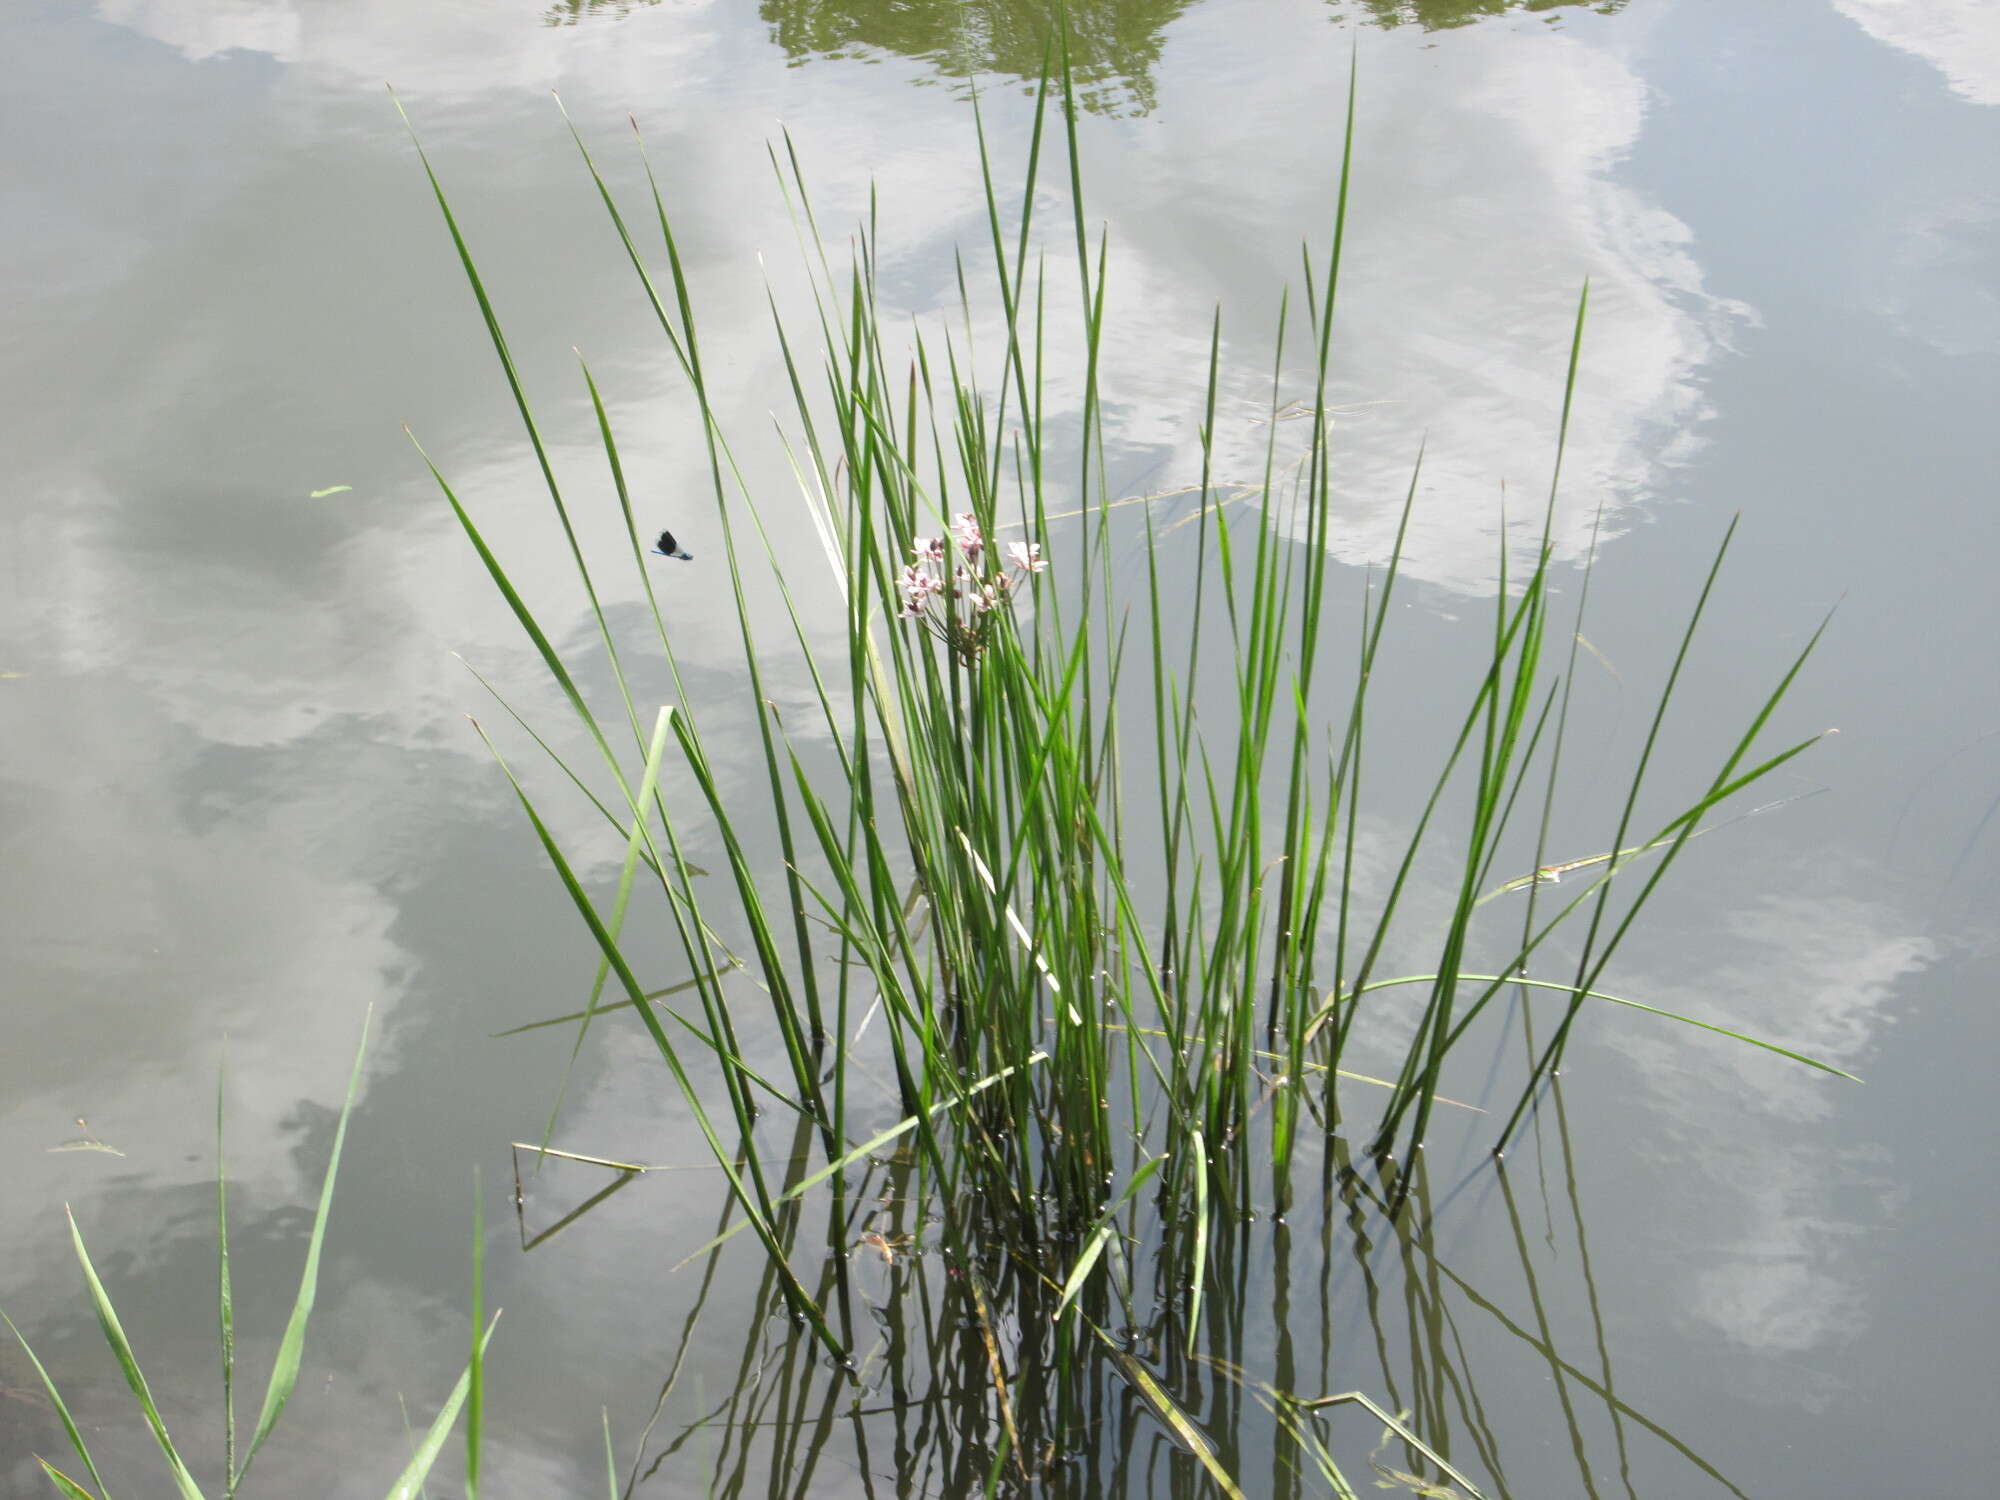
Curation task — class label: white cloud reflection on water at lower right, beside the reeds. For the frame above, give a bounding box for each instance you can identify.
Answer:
[1586,852,1942,1410]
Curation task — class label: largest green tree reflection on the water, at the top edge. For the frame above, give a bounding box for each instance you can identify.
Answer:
[756,0,1192,114]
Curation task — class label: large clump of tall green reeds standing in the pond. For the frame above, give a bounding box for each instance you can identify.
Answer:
[402,29,1824,1472]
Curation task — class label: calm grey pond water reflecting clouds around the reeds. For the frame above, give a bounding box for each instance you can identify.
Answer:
[0,0,2000,1500]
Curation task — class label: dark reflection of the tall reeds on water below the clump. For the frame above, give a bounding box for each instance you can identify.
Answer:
[540,1086,1744,1500]
